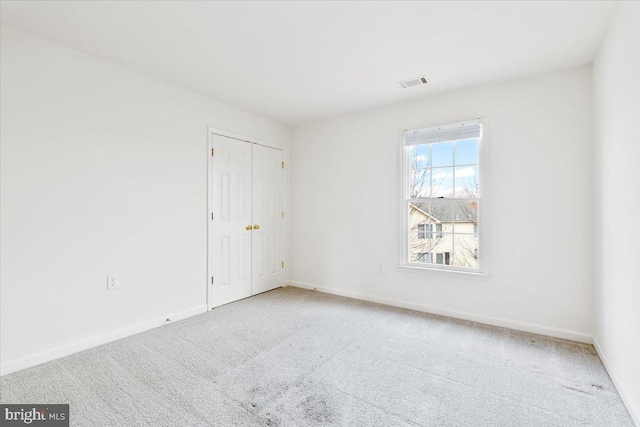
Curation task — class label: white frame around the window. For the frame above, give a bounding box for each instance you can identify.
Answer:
[398,119,491,278]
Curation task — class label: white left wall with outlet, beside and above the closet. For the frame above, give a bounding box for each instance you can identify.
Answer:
[0,26,289,373]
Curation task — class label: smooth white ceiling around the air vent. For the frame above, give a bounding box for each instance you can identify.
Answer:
[1,1,616,124]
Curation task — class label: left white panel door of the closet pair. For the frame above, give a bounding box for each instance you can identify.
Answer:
[208,135,253,307]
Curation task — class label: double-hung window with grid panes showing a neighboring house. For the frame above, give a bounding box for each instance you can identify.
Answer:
[402,120,483,271]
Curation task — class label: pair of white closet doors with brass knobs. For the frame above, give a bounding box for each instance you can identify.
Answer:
[207,134,285,307]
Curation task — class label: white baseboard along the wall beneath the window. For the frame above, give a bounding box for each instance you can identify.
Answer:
[287,280,593,344]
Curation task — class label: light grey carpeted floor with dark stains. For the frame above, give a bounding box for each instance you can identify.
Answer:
[0,287,633,427]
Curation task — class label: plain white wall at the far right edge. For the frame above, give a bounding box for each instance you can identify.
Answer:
[593,2,640,426]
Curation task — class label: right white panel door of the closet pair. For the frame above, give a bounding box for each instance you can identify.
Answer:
[252,145,285,295]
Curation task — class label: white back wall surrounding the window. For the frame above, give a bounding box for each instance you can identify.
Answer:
[289,66,593,341]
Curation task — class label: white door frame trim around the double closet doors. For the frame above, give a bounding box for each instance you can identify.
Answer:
[205,126,289,310]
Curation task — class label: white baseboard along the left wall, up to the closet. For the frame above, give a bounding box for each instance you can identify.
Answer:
[0,304,207,375]
